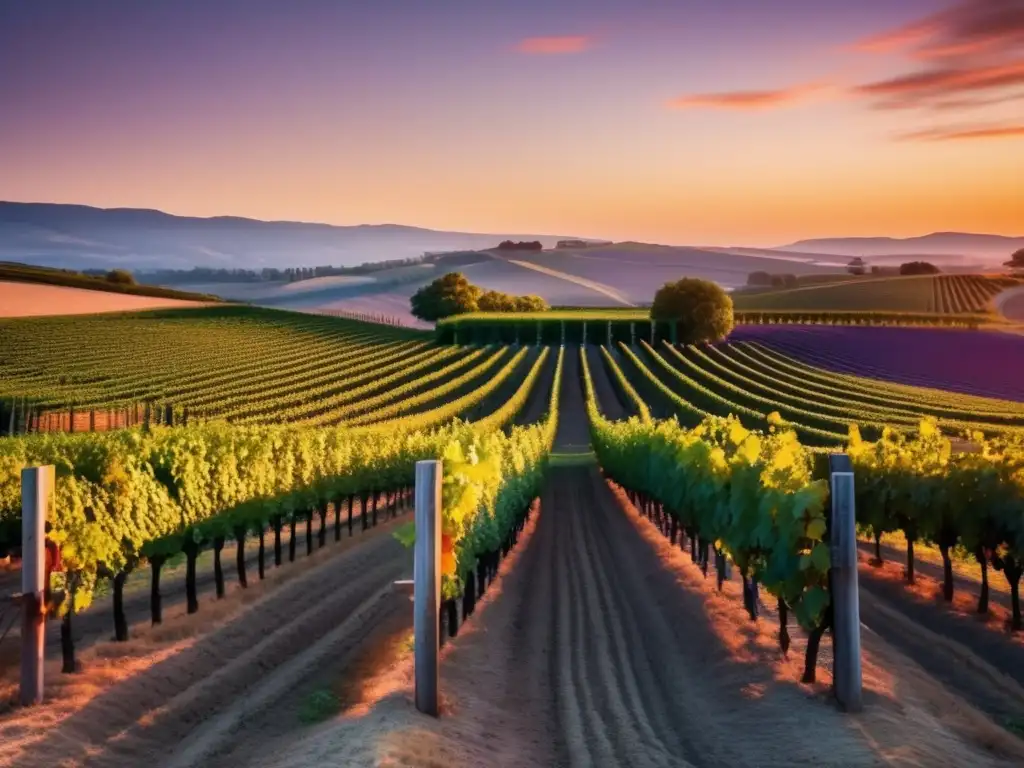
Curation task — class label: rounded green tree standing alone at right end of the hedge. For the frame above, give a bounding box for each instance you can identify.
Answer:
[650,278,735,344]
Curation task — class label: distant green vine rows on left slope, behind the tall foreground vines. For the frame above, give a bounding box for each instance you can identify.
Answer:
[0,307,552,433]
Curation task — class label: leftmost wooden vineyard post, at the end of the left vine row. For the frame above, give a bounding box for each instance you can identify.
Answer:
[20,465,54,707]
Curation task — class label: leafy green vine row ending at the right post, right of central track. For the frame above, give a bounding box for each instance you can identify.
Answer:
[581,348,829,629]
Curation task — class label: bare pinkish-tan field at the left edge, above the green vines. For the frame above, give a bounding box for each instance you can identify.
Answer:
[0,281,208,317]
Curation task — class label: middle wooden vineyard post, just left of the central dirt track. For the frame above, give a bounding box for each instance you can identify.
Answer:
[413,460,441,717]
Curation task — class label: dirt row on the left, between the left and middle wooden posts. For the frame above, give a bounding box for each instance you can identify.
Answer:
[0,518,412,768]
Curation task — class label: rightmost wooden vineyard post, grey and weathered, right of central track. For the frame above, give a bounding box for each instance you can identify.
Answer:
[828,454,862,712]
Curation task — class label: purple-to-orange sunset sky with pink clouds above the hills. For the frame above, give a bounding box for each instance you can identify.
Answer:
[0,0,1024,246]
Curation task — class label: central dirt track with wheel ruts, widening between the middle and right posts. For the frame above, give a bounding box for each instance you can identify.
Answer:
[239,467,1024,768]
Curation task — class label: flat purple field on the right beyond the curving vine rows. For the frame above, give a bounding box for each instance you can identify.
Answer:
[729,326,1024,402]
